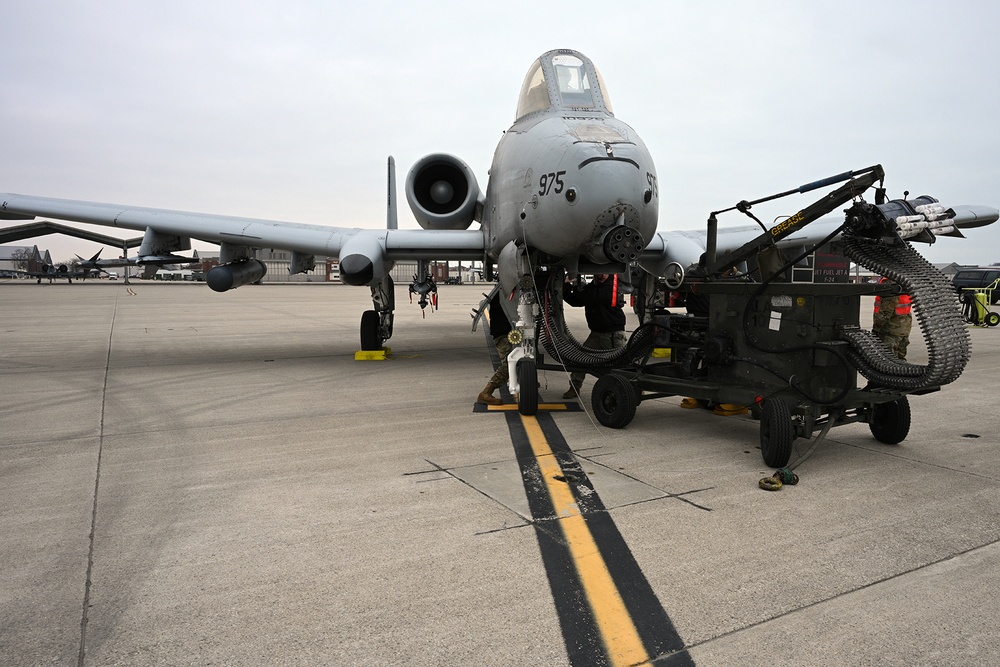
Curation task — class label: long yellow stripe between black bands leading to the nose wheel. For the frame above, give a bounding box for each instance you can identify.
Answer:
[521,415,652,667]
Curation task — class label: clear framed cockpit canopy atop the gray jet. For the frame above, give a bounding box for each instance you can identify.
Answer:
[517,51,614,118]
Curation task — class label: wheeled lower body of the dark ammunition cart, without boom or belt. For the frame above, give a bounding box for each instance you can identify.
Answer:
[592,283,924,467]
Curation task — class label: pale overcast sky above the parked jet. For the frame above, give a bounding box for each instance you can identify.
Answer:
[0,0,1000,264]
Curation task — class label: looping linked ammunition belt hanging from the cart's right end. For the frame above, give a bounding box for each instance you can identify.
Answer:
[841,233,971,390]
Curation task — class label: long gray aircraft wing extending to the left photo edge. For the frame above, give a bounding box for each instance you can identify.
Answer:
[0,194,485,284]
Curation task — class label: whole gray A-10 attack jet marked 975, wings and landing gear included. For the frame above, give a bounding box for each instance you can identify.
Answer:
[0,50,1000,414]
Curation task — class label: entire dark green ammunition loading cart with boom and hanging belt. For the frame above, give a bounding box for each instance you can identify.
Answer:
[576,165,970,467]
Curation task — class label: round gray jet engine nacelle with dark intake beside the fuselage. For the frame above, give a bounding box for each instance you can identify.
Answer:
[406,153,482,229]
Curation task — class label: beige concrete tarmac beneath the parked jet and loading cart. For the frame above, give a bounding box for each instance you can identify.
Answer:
[0,280,1000,666]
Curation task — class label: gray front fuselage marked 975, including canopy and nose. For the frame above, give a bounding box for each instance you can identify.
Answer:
[482,50,658,269]
